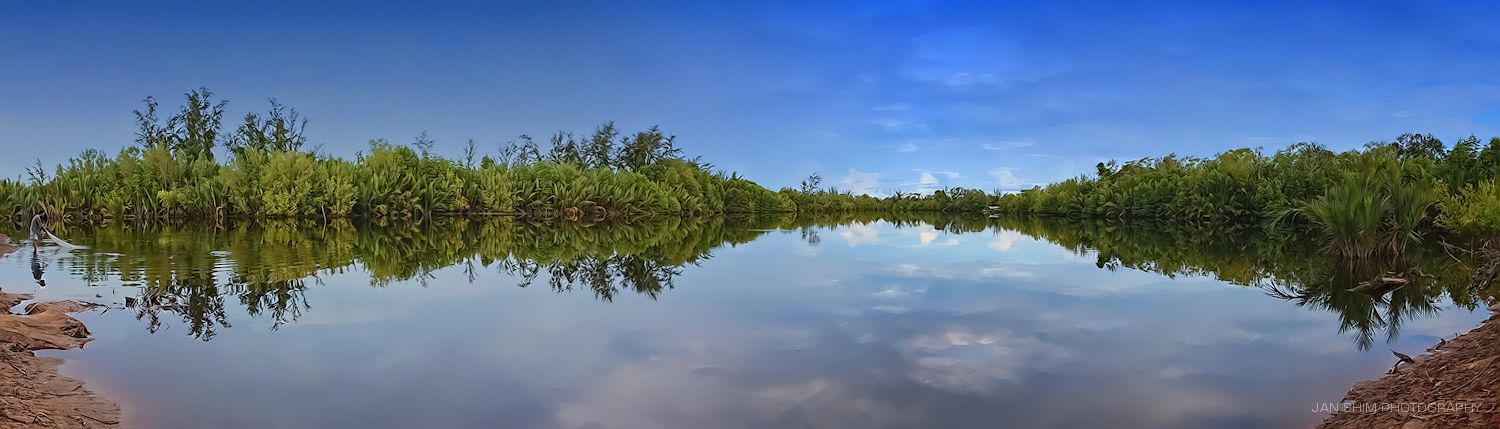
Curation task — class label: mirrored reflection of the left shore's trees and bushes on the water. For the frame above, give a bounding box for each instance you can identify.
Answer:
[52,218,770,341]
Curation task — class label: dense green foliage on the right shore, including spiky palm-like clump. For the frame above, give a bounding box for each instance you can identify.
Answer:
[998,134,1500,257]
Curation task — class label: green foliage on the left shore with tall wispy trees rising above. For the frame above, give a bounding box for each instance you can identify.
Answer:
[0,89,992,221]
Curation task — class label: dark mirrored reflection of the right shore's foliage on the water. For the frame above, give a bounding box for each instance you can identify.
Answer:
[998,218,1481,350]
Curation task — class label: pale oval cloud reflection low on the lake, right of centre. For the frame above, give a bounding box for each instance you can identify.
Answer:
[902,332,1067,393]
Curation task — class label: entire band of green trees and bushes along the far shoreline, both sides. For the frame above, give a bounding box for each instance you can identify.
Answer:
[0,89,1500,261]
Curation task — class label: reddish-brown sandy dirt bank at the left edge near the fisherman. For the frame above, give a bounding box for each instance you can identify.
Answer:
[0,236,120,428]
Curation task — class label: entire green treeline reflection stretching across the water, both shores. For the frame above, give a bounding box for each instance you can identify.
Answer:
[8,213,1490,350]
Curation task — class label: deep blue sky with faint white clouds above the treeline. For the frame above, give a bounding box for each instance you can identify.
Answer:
[0,0,1500,194]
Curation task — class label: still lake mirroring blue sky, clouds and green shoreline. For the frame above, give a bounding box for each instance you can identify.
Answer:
[0,216,1488,428]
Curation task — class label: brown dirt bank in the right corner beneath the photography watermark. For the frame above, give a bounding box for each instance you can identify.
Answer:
[1319,306,1500,429]
